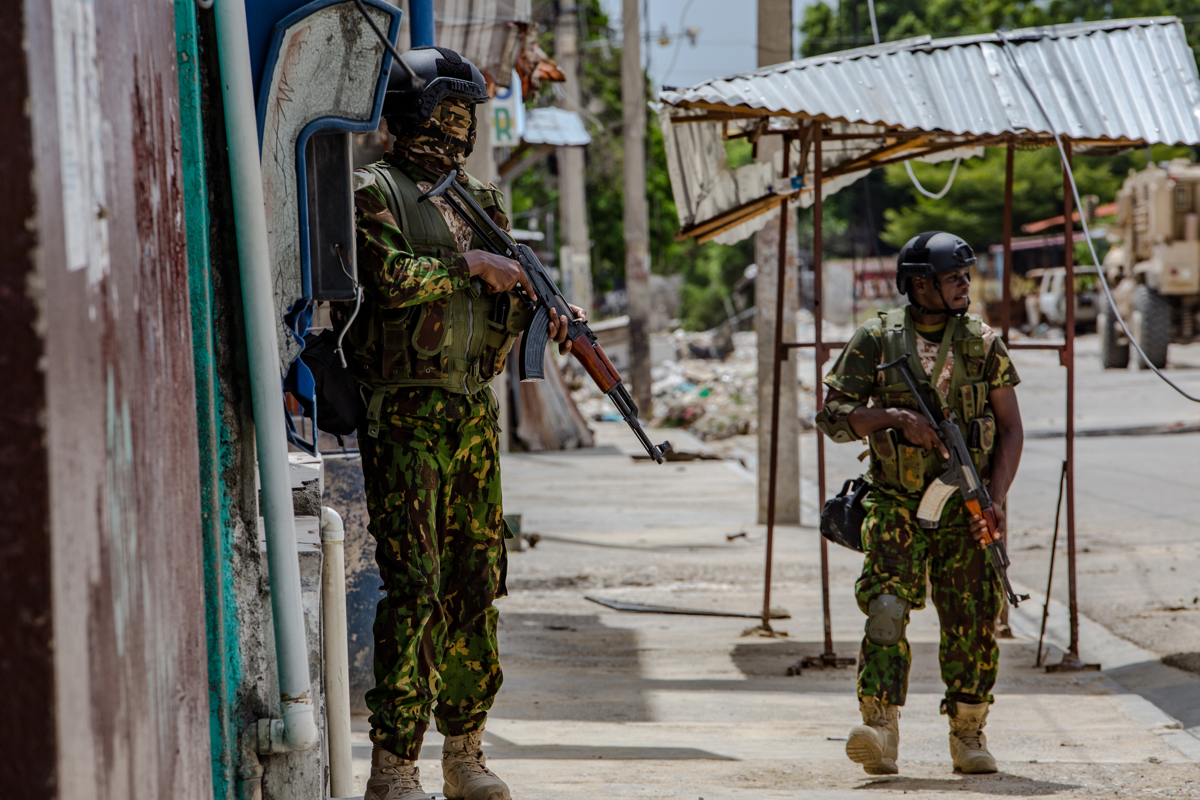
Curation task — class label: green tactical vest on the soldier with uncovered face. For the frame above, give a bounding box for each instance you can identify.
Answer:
[869,307,996,494]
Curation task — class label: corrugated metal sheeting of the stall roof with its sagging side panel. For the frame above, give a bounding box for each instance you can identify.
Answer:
[660,17,1200,243]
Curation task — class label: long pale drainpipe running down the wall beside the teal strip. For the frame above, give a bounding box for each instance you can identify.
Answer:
[216,0,318,750]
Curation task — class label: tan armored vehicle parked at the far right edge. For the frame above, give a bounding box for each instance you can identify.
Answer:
[1097,160,1200,368]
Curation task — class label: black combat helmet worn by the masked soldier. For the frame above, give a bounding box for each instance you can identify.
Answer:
[383,47,488,154]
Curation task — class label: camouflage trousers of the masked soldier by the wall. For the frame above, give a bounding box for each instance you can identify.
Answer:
[359,402,508,759]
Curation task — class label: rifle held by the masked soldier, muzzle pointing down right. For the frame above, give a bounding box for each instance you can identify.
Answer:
[419,169,671,464]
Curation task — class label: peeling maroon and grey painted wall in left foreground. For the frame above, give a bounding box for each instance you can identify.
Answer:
[0,0,212,800]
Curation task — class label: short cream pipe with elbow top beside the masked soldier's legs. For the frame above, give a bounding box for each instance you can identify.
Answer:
[320,509,354,798]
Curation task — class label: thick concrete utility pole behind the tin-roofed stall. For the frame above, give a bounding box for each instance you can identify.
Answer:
[755,0,803,525]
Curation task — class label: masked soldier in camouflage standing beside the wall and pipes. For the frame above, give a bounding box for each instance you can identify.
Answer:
[350,48,583,800]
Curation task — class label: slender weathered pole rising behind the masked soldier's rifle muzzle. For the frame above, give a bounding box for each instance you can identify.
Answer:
[620,0,652,419]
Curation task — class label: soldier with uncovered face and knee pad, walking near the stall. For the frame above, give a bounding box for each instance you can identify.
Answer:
[817,231,1024,775]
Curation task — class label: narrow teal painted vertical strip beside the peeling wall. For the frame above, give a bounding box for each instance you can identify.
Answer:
[175,0,241,800]
